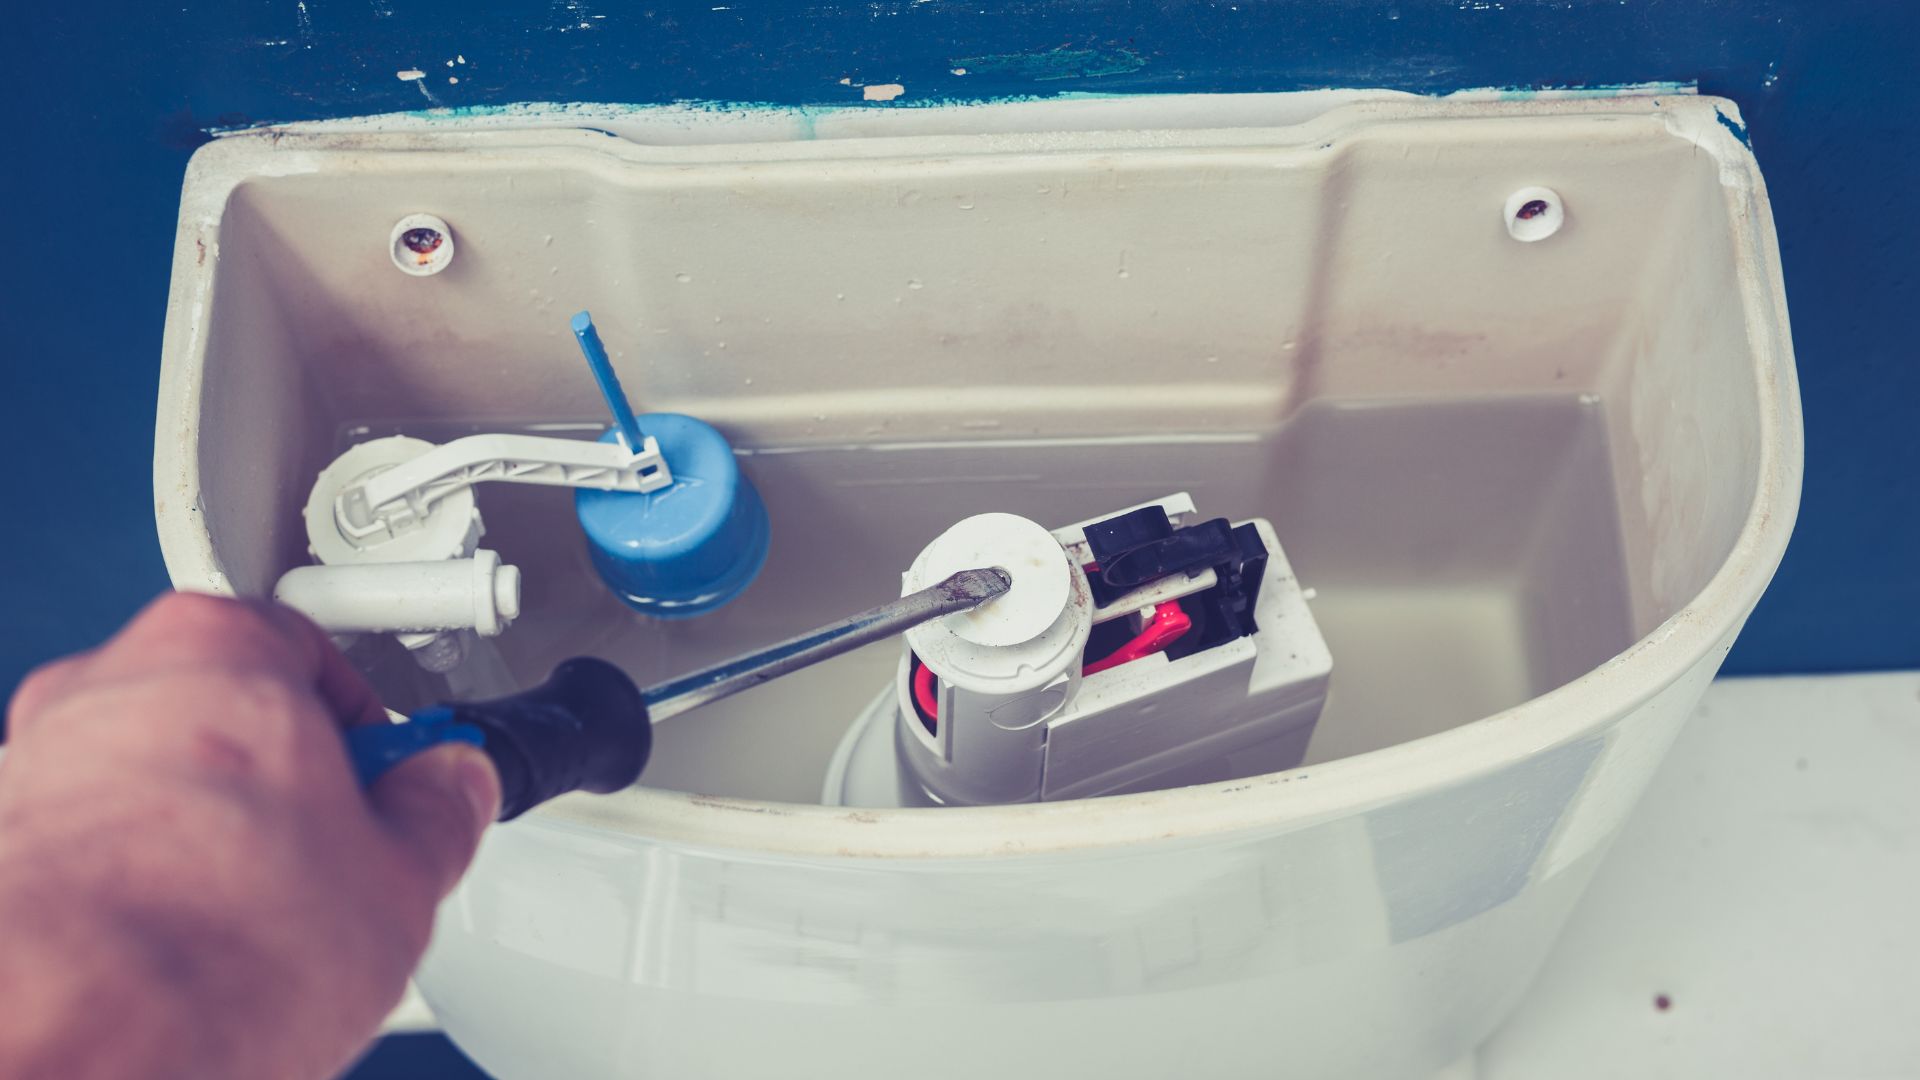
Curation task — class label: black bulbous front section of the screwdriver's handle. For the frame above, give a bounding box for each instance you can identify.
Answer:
[445,657,653,821]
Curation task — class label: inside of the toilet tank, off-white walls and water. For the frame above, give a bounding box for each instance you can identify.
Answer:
[172,110,1759,801]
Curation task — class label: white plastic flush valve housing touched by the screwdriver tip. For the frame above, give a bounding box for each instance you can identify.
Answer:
[887,492,1332,805]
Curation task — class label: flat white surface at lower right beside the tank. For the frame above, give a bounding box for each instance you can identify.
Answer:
[1478,673,1920,1080]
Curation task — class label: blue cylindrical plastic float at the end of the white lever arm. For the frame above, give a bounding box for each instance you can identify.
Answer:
[574,413,770,619]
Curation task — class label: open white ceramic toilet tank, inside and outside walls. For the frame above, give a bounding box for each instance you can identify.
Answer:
[156,96,1801,1078]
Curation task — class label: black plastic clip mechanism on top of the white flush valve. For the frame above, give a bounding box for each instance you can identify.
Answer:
[1087,505,1267,659]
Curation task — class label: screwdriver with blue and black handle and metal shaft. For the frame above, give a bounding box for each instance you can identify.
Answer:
[344,569,1014,821]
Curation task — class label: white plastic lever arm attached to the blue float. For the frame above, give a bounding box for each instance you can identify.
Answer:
[334,434,674,544]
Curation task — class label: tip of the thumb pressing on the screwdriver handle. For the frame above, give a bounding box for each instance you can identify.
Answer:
[371,742,499,897]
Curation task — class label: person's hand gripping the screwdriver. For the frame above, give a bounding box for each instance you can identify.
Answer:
[0,594,499,1080]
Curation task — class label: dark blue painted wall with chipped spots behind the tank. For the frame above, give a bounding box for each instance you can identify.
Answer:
[0,0,1920,1074]
